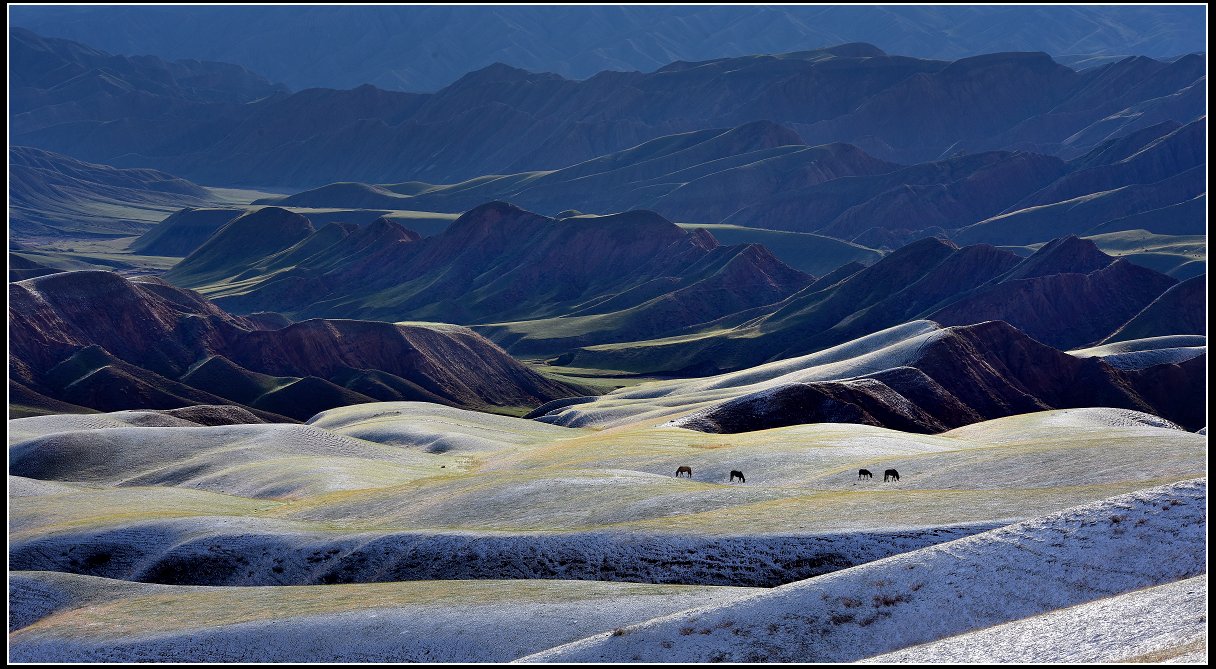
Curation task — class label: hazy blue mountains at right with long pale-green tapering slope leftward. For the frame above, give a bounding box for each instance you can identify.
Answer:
[259,119,1206,253]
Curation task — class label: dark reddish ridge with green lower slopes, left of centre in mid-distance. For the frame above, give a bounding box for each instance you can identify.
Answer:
[165,202,812,348]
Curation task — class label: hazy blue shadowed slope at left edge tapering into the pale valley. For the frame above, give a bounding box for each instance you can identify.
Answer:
[9,146,215,240]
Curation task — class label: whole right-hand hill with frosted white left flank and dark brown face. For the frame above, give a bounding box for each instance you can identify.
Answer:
[529,320,1206,433]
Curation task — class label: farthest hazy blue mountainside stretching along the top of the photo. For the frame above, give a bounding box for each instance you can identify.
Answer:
[11,5,1205,91]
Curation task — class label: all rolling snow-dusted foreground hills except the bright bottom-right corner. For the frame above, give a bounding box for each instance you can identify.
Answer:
[9,403,1207,662]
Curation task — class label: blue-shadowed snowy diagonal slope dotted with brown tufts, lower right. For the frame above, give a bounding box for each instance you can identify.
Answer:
[523,479,1207,662]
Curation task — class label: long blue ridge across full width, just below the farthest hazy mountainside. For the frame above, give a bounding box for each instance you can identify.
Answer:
[13,27,1205,187]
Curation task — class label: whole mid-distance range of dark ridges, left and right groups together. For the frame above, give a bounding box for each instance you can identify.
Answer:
[138,202,1194,375]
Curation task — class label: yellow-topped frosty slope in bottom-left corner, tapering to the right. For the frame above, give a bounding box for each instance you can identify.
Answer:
[10,572,753,662]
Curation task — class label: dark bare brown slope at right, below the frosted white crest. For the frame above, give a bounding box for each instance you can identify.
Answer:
[674,321,1206,432]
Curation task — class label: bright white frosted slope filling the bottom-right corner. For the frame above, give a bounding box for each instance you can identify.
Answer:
[862,575,1207,664]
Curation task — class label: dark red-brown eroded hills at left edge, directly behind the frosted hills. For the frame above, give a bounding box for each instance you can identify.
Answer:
[9,271,576,420]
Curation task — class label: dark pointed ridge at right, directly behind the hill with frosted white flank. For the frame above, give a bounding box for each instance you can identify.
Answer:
[556,237,1194,373]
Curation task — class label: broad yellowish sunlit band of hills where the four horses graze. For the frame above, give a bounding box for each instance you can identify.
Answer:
[10,403,1205,542]
